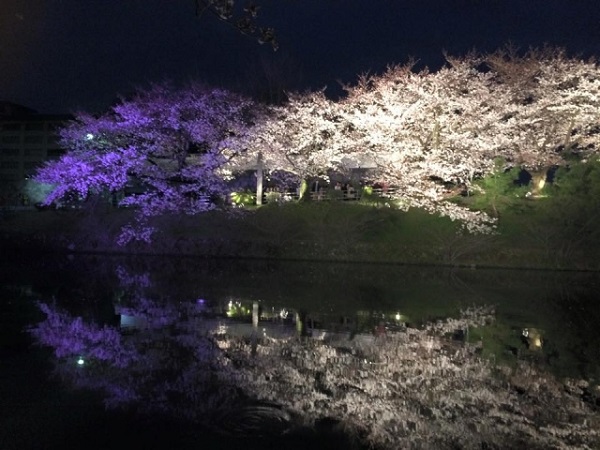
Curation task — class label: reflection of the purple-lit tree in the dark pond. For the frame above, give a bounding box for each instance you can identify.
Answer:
[31,300,237,420]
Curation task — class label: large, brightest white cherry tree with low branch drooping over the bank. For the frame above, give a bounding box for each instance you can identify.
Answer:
[326,61,508,230]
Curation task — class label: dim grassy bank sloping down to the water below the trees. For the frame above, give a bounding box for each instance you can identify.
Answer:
[0,200,600,270]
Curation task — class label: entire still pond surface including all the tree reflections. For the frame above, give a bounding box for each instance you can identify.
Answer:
[0,255,600,449]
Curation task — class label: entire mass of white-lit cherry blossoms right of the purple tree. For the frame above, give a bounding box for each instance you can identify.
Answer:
[247,49,600,230]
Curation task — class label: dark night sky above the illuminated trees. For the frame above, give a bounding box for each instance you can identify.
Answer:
[0,0,600,113]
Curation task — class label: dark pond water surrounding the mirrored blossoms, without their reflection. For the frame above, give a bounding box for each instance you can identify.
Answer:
[0,255,600,449]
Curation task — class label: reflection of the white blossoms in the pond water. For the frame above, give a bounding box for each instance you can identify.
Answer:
[217,309,600,449]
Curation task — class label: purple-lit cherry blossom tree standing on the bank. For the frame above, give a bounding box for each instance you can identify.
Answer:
[36,84,252,240]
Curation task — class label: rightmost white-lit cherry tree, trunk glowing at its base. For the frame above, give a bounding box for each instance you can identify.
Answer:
[484,47,600,191]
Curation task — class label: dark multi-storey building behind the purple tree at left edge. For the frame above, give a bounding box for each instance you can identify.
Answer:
[0,101,73,207]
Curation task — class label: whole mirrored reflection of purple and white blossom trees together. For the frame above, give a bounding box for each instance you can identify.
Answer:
[15,255,600,449]
